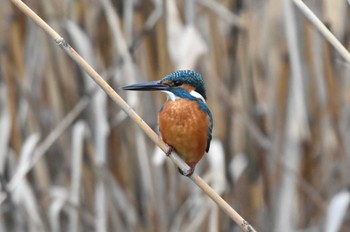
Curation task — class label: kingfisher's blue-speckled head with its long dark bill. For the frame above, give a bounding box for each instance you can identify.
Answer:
[122,70,207,102]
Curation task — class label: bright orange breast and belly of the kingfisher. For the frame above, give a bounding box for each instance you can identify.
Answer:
[158,98,209,167]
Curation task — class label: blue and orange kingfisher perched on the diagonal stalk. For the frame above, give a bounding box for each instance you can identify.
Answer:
[122,70,213,176]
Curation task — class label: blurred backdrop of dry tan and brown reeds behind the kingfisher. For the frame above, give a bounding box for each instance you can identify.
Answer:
[0,0,350,232]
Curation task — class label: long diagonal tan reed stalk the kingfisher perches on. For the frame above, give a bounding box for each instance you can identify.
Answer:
[11,0,255,232]
